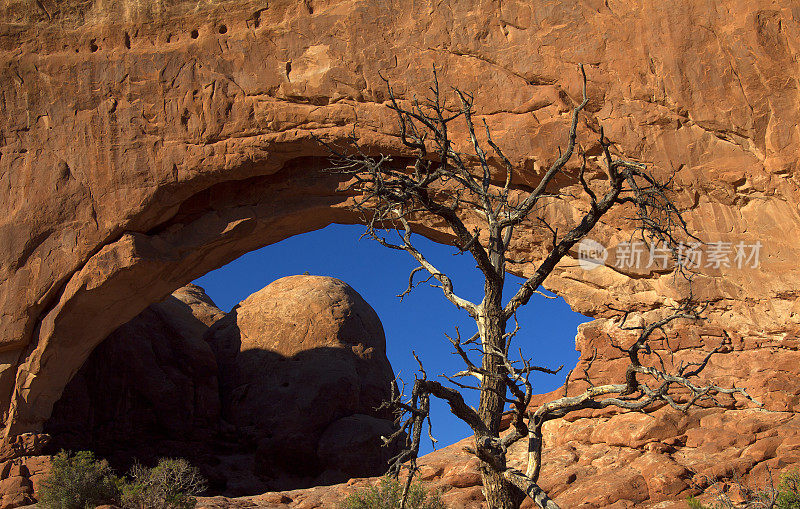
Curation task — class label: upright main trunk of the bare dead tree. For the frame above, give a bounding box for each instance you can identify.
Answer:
[476,281,525,509]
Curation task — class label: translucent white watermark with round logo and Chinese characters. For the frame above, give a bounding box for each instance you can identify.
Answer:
[578,238,762,270]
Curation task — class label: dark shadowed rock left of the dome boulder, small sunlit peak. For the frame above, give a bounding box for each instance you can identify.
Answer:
[44,285,224,480]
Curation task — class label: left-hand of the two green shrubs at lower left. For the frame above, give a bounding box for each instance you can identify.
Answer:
[39,451,121,509]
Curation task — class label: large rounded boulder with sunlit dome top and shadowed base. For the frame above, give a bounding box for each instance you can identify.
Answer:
[207,276,394,486]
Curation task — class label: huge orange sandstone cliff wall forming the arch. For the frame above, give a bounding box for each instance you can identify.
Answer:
[0,0,800,505]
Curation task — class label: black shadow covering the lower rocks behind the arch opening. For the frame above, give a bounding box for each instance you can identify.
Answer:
[45,296,393,496]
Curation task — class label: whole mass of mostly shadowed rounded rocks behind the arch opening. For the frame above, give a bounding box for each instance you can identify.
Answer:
[40,276,394,495]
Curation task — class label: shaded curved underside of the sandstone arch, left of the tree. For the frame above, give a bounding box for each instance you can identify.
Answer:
[2,160,362,434]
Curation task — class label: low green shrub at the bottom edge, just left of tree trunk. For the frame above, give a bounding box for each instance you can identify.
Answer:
[340,476,445,509]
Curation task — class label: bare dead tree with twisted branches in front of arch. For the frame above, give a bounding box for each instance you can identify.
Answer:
[318,67,749,509]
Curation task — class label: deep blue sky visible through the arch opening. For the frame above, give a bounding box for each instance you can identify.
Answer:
[195,225,589,453]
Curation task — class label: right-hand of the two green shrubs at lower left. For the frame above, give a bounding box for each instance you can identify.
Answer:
[122,458,206,509]
